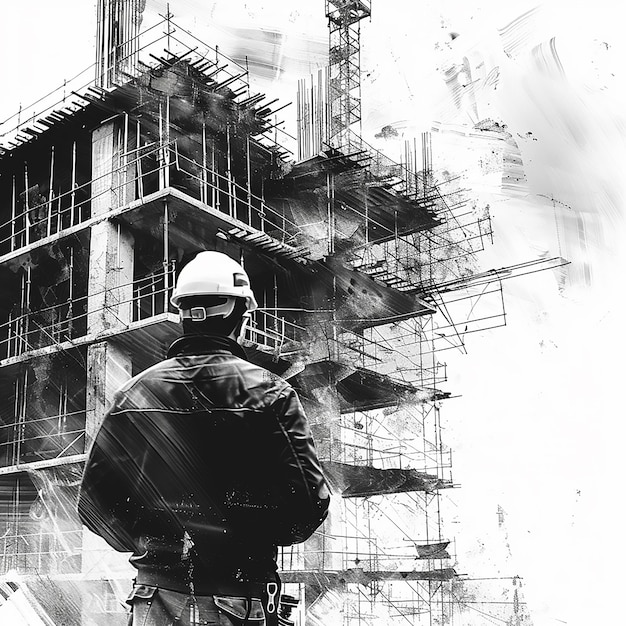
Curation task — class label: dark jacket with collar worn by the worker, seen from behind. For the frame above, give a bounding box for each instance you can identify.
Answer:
[78,335,330,592]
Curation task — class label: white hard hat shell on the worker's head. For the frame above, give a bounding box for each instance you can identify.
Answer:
[171,250,257,312]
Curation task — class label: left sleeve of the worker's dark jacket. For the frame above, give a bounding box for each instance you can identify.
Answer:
[77,392,135,552]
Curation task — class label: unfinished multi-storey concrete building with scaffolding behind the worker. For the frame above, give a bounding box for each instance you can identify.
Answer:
[0,0,556,626]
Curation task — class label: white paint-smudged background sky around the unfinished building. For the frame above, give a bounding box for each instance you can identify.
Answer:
[0,0,626,626]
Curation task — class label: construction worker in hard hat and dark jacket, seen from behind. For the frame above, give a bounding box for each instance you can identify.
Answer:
[78,251,330,626]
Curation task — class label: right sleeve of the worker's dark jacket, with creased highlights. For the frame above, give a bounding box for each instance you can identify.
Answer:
[270,387,330,545]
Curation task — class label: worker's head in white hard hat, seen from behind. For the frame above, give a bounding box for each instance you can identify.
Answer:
[171,251,257,341]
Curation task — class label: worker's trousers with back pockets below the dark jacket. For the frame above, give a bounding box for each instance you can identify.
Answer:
[127,585,266,626]
